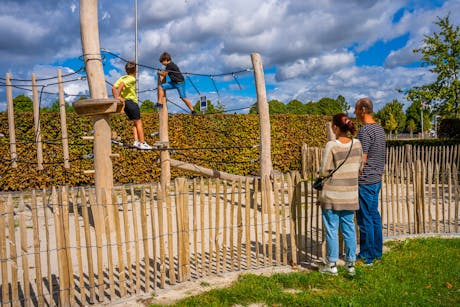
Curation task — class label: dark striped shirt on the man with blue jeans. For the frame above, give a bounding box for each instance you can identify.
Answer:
[358,124,386,184]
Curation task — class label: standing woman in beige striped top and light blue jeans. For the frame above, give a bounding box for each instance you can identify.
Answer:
[319,113,362,275]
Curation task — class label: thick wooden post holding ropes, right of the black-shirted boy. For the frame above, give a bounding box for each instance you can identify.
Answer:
[251,53,273,178]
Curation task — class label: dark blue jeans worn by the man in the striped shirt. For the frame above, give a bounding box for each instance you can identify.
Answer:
[356,182,383,263]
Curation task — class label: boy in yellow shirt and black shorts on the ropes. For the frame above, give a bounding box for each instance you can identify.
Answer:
[112,62,152,149]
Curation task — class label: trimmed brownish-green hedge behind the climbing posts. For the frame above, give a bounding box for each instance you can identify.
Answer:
[0,112,331,191]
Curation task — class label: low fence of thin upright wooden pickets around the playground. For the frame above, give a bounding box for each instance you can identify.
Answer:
[0,147,459,306]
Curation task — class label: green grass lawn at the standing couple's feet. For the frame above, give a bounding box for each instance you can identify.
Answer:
[151,238,460,306]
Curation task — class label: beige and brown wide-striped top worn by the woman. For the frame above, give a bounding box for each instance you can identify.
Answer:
[319,139,363,211]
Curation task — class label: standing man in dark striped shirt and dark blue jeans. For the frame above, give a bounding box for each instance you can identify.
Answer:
[355,98,386,265]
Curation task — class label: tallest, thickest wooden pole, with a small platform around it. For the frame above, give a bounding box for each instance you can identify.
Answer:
[80,0,113,229]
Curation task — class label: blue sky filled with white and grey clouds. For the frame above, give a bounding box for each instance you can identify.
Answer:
[0,0,460,113]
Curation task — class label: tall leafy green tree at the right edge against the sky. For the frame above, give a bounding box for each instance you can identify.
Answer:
[406,15,460,118]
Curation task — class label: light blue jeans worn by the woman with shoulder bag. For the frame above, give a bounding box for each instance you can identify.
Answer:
[322,209,356,262]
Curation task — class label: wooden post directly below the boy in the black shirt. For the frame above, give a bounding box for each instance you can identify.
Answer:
[158,74,171,189]
